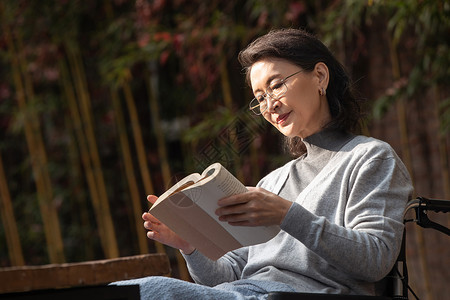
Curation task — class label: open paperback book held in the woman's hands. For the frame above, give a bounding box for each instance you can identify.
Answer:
[149,163,280,260]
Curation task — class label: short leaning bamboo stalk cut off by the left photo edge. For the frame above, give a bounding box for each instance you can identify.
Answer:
[0,152,25,266]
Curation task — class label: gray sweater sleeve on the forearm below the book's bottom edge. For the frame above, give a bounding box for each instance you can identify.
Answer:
[183,247,248,286]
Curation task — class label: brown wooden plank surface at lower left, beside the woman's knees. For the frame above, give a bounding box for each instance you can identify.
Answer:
[0,254,171,299]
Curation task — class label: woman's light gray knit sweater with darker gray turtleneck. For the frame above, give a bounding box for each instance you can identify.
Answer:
[184,130,412,295]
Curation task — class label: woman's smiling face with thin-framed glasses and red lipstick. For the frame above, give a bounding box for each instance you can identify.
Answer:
[250,59,331,138]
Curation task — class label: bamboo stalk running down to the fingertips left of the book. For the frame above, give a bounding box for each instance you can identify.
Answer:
[122,81,166,253]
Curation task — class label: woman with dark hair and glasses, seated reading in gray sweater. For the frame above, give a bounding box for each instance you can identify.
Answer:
[111,29,412,299]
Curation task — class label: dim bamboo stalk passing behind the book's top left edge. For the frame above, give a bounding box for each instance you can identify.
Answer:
[145,62,190,280]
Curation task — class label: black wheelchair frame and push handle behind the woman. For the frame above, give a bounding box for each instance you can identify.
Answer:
[267,197,450,300]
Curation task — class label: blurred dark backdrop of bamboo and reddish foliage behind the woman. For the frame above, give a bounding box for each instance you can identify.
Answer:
[0,0,450,299]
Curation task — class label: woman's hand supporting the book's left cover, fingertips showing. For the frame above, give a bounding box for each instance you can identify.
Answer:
[142,195,195,254]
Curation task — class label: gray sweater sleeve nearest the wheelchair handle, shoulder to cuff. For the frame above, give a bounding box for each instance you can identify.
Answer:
[281,157,412,282]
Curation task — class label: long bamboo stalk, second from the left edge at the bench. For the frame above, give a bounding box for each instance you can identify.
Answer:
[3,25,65,263]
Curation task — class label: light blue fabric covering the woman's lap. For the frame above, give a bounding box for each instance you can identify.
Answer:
[111,276,294,300]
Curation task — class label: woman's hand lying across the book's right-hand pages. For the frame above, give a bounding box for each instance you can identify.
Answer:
[216,187,292,226]
